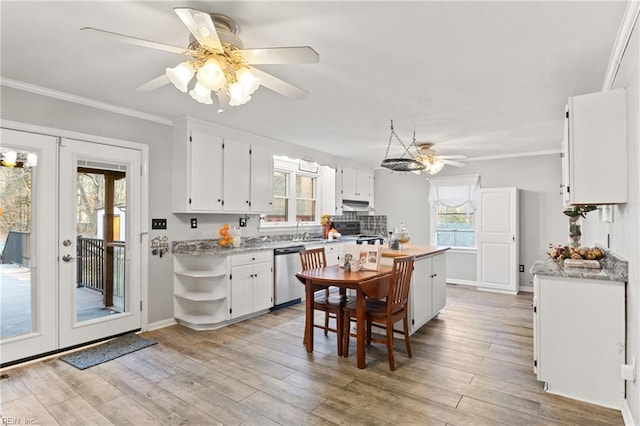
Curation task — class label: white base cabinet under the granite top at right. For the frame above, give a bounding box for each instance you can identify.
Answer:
[533,275,625,409]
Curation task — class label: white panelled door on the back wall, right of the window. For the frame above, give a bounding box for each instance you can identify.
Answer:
[477,188,519,294]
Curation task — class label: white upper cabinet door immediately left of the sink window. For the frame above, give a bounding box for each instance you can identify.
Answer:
[250,145,273,213]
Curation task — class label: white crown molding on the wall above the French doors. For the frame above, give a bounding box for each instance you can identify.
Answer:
[0,77,173,126]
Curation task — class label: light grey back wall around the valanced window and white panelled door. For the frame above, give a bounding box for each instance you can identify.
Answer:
[375,153,568,287]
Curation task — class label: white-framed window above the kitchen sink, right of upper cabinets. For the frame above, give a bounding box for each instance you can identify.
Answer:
[262,157,319,227]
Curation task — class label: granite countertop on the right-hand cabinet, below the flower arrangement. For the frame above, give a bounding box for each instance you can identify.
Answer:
[529,252,629,282]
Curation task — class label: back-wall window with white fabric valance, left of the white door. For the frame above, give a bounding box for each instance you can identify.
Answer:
[429,175,480,249]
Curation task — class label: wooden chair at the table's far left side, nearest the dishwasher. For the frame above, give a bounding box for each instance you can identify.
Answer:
[300,247,347,356]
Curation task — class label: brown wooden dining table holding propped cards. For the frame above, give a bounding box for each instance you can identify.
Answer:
[296,265,392,368]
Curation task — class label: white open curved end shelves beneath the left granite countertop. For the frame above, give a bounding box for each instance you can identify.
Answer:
[174,254,229,330]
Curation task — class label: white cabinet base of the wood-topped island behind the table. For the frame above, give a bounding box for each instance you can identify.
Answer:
[381,253,447,334]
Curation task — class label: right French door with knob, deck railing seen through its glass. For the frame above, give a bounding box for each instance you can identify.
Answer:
[58,139,142,348]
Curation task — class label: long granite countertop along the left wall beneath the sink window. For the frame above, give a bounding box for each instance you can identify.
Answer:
[171,236,357,256]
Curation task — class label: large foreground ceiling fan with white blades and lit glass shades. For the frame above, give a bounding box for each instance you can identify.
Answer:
[81,7,320,112]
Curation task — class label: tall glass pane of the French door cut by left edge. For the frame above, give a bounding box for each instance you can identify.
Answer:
[0,150,37,339]
